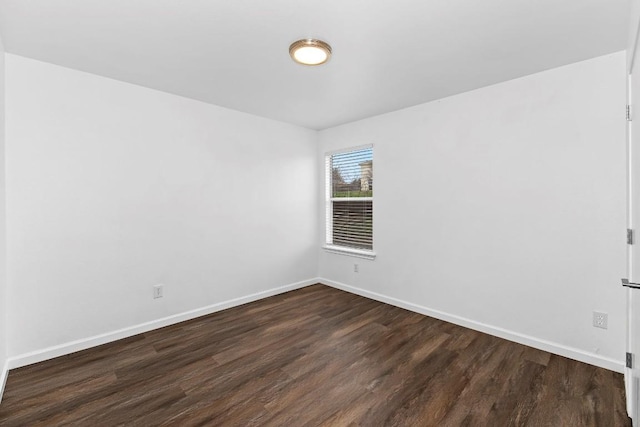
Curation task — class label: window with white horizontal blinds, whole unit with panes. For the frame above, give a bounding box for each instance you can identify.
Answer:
[325,146,375,258]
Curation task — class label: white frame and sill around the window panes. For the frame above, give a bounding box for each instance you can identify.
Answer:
[322,144,376,260]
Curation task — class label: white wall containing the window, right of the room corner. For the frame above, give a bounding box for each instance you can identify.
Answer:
[318,52,625,370]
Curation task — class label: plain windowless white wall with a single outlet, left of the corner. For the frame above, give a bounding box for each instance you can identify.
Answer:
[6,55,317,366]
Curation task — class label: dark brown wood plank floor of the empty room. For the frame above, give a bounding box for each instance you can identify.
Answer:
[0,285,630,426]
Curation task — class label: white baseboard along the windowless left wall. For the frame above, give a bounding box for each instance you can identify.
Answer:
[8,278,319,372]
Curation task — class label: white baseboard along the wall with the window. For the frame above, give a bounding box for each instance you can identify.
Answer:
[318,278,625,373]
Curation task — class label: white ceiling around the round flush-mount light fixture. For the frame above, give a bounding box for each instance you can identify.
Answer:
[0,0,629,129]
